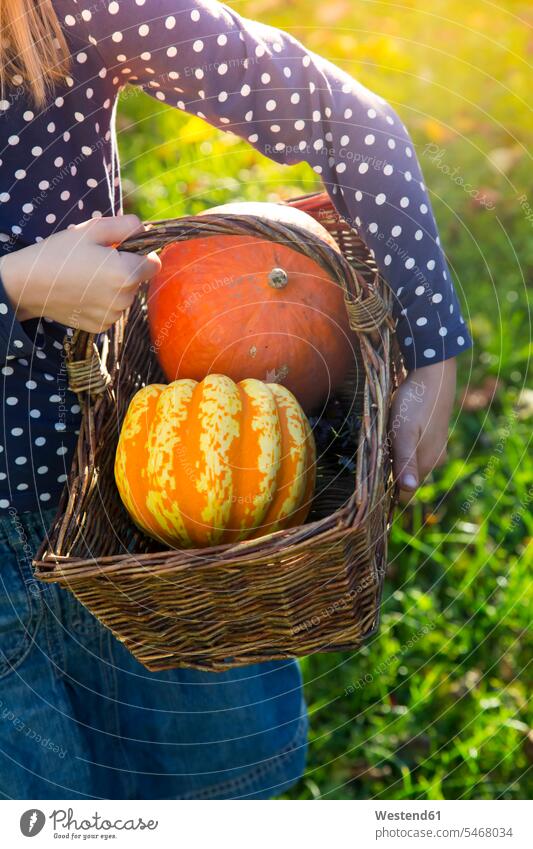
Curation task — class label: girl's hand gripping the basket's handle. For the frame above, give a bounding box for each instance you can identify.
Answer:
[0,215,161,333]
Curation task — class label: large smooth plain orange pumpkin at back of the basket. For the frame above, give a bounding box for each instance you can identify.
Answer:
[148,203,354,411]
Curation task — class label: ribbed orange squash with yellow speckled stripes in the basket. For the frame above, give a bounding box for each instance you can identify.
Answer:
[115,375,315,548]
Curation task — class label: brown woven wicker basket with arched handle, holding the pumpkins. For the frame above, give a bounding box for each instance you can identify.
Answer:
[34,192,402,670]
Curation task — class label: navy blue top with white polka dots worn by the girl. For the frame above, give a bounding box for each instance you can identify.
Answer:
[0,0,471,511]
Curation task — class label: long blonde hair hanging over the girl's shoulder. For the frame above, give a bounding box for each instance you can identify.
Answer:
[0,0,70,106]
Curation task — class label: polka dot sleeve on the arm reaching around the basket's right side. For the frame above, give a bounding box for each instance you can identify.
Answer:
[71,0,471,369]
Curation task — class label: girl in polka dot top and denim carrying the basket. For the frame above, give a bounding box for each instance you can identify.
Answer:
[0,0,470,799]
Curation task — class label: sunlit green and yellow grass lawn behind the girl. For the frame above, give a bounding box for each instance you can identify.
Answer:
[118,0,533,799]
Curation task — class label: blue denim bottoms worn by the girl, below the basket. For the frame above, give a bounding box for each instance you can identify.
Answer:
[0,510,307,799]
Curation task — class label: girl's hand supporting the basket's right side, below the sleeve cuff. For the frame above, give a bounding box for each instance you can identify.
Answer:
[389,359,456,504]
